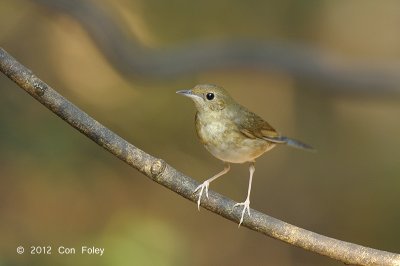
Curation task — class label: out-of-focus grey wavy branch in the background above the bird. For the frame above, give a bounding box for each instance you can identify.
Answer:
[35,0,400,95]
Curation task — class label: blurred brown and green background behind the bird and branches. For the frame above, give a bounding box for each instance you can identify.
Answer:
[0,0,400,265]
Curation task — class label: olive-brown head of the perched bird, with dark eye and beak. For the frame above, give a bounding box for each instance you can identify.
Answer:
[176,84,233,112]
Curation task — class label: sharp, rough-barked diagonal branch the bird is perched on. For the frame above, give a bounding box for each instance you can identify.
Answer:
[0,48,400,265]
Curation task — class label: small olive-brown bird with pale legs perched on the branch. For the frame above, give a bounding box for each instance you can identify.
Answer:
[177,84,313,226]
